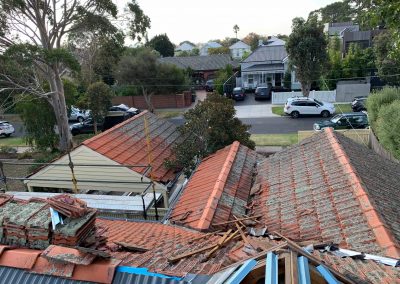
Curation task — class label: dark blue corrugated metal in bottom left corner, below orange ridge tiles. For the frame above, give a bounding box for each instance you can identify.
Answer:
[0,266,91,284]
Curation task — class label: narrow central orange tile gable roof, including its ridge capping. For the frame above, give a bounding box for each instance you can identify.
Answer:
[170,142,256,230]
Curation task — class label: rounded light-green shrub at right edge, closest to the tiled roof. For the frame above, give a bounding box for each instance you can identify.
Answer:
[375,100,400,159]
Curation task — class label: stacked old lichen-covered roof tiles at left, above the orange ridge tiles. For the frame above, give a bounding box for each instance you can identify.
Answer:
[0,196,96,249]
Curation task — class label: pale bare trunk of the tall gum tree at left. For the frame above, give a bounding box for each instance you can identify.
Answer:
[49,69,72,152]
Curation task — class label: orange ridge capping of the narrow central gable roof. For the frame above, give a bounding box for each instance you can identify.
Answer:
[198,141,240,230]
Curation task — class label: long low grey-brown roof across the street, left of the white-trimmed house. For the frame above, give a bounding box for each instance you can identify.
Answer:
[159,54,239,71]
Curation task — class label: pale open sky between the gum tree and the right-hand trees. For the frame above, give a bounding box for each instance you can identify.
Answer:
[114,0,337,44]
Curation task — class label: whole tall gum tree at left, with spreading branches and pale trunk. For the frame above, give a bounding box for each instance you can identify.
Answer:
[0,0,150,151]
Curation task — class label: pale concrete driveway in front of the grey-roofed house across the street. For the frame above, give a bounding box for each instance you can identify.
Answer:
[235,93,279,119]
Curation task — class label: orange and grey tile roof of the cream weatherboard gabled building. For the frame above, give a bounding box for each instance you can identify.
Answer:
[83,111,180,183]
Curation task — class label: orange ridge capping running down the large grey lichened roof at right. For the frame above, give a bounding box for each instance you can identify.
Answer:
[324,128,400,258]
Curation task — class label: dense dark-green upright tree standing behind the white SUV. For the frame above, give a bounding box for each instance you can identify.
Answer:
[286,17,328,96]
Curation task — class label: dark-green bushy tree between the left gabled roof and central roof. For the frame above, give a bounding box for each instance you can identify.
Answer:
[167,94,255,176]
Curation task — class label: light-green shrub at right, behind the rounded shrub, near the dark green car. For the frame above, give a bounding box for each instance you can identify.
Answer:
[367,87,400,128]
